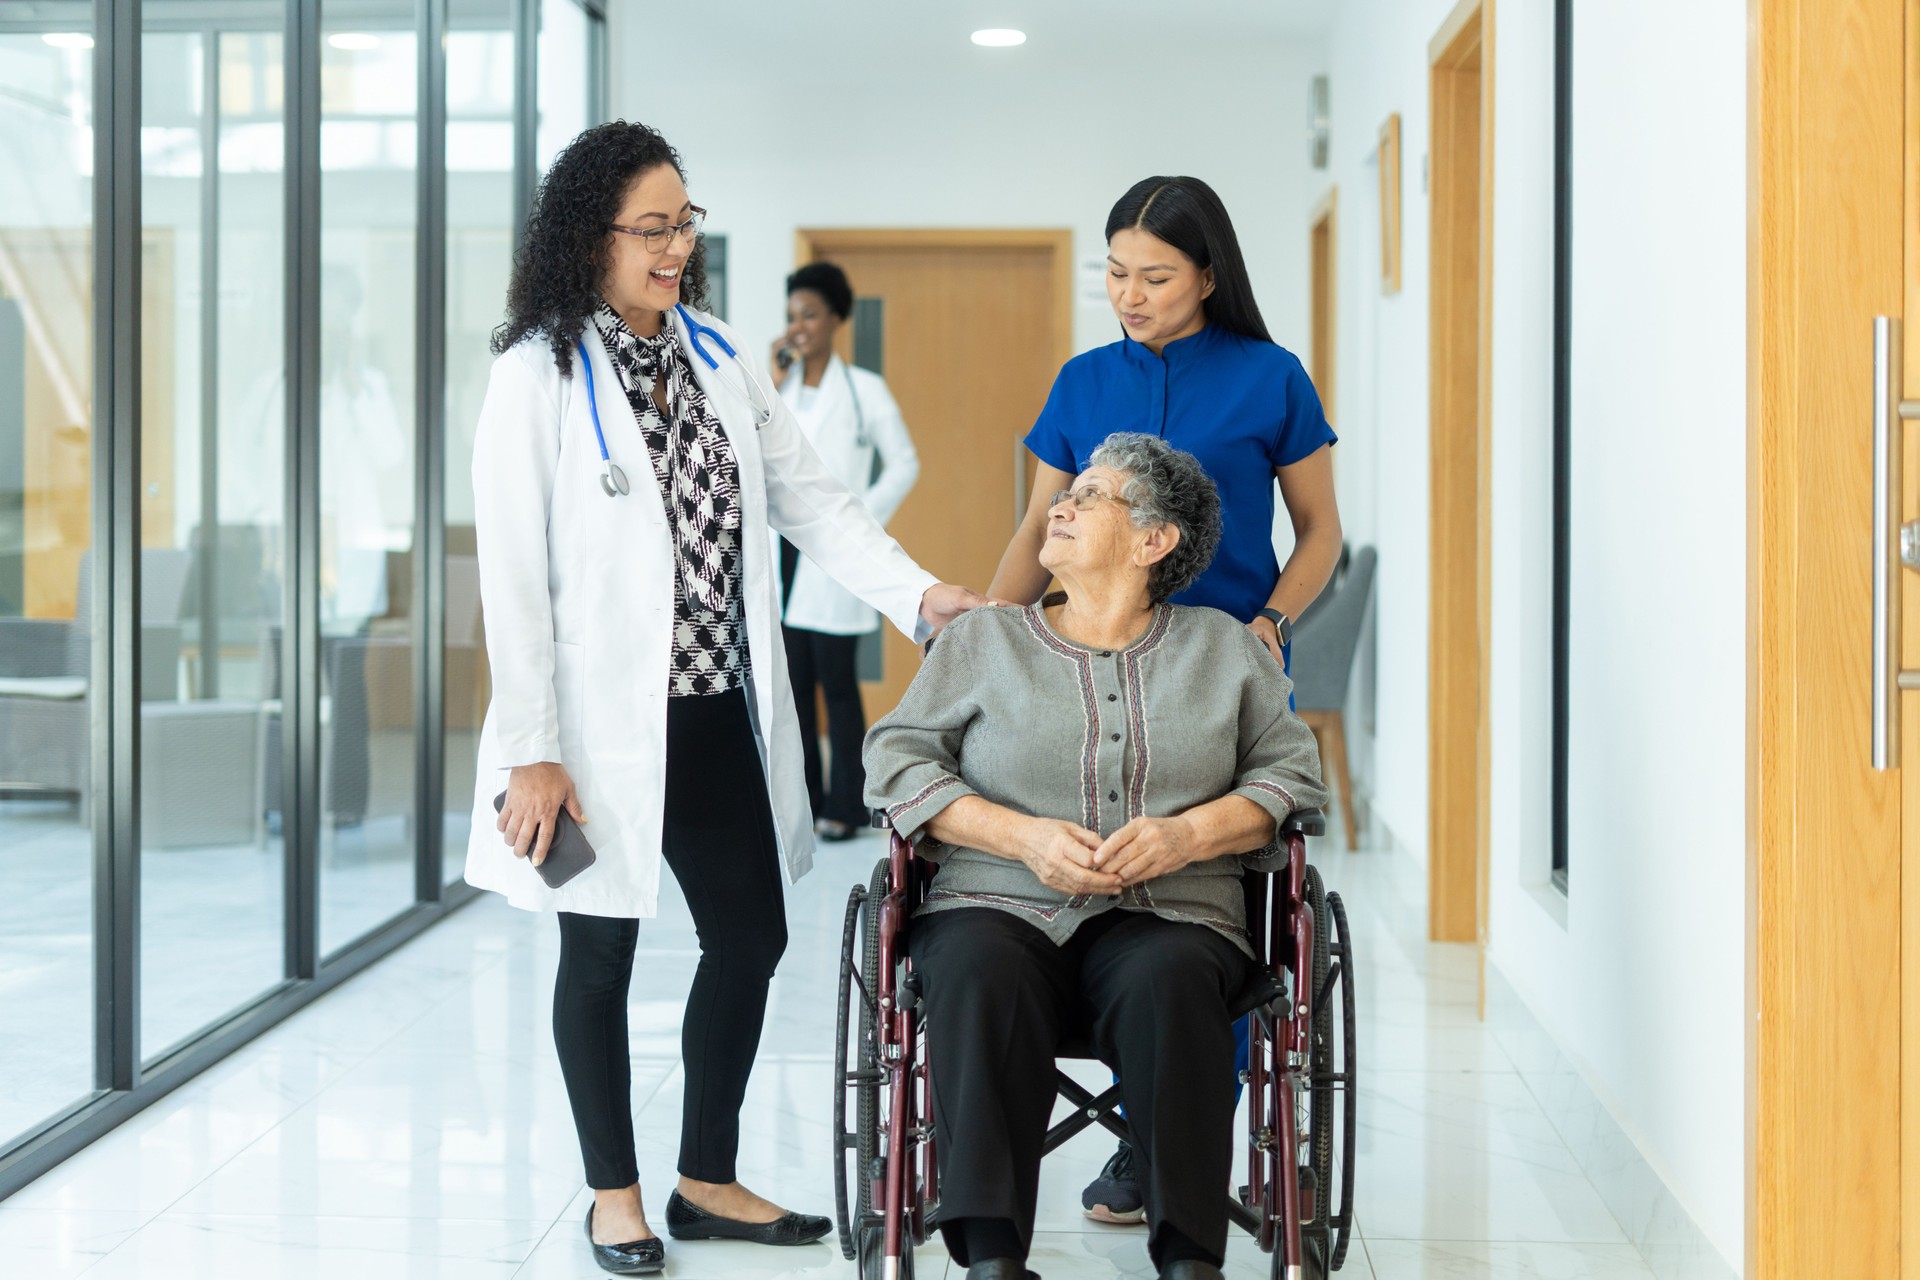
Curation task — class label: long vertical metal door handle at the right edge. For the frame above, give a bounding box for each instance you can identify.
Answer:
[1872,315,1920,770]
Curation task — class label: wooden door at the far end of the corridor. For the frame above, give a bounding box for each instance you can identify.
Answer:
[799,230,1073,723]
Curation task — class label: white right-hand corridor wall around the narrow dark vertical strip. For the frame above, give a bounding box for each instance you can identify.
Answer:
[1329,0,1745,1268]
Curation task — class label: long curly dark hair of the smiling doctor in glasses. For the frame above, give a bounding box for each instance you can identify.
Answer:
[493,121,707,374]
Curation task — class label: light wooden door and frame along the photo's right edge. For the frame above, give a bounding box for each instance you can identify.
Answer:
[1745,0,1920,1280]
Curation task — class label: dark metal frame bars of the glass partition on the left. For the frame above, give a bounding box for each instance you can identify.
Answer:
[0,0,607,1199]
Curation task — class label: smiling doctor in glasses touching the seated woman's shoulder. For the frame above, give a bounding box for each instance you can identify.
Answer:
[467,123,983,1274]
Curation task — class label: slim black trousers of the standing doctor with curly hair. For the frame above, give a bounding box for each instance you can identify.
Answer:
[553,689,787,1190]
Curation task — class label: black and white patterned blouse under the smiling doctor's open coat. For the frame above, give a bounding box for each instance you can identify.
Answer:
[593,303,749,699]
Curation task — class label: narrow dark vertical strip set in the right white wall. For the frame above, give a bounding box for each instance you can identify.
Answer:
[1549,0,1572,892]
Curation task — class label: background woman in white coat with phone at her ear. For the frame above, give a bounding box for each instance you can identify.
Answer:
[774,263,920,841]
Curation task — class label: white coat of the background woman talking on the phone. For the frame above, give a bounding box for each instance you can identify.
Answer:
[774,355,920,635]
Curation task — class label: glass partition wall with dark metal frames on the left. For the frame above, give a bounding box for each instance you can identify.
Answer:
[0,0,605,1197]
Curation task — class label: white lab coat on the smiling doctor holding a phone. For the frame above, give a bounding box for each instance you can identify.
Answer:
[467,313,935,917]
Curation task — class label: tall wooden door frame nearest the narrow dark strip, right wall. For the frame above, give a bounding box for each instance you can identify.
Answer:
[1427,0,1494,950]
